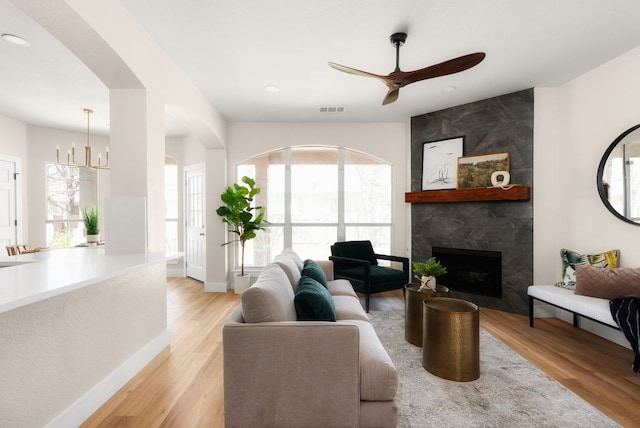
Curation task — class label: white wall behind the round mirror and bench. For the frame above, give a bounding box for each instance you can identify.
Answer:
[533,47,640,284]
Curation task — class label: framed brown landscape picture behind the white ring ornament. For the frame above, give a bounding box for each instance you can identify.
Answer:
[458,152,509,189]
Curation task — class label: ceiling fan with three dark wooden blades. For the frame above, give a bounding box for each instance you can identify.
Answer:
[329,33,485,105]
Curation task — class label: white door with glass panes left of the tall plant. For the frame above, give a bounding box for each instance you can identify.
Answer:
[185,166,207,282]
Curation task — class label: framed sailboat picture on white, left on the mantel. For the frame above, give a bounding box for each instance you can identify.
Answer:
[422,137,464,190]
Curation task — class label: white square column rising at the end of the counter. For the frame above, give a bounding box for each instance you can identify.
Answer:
[105,89,165,253]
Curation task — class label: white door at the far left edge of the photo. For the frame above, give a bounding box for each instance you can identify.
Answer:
[0,159,18,247]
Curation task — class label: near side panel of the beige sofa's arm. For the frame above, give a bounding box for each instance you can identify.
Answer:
[223,321,360,428]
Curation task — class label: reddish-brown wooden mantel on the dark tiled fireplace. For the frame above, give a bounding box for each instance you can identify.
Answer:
[404,184,529,204]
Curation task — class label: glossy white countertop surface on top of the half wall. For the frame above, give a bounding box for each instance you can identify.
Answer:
[0,247,174,313]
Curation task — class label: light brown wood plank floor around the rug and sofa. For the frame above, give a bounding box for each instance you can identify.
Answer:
[82,279,640,428]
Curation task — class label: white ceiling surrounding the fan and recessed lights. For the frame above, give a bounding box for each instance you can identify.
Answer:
[0,0,640,135]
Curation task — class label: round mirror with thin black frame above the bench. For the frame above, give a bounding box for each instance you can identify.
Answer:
[597,124,640,226]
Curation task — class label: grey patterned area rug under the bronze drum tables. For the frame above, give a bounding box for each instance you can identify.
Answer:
[369,310,619,428]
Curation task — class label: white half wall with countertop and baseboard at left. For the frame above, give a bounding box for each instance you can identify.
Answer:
[0,247,176,428]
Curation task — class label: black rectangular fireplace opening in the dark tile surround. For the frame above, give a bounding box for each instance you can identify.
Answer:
[432,247,502,298]
